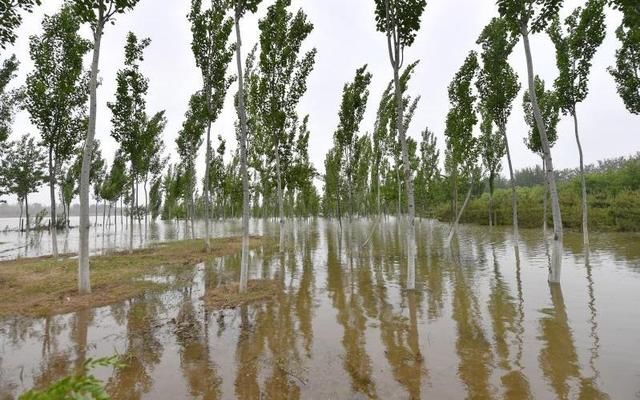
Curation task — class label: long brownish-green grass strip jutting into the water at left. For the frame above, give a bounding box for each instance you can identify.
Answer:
[0,237,261,316]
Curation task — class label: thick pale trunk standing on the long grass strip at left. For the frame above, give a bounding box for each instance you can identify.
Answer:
[78,17,104,293]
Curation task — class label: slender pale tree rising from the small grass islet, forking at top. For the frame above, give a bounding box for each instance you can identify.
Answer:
[228,0,262,293]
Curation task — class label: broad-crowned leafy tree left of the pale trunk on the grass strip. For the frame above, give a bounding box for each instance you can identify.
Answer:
[24,7,91,258]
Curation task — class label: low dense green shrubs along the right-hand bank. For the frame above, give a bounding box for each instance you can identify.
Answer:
[435,153,640,231]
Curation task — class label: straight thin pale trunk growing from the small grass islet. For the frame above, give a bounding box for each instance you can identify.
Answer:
[235,10,251,293]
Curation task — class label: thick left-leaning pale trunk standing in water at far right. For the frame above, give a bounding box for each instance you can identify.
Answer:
[521,26,562,283]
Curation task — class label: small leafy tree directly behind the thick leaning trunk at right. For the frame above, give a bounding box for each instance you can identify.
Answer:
[522,76,560,231]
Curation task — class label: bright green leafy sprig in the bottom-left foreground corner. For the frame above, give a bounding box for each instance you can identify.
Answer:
[19,356,124,400]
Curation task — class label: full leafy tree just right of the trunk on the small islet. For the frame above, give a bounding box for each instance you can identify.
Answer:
[258,0,316,250]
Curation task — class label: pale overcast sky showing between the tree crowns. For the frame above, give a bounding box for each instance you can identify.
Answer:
[2,0,640,204]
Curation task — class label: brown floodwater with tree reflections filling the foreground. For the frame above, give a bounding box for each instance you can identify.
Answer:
[0,219,640,400]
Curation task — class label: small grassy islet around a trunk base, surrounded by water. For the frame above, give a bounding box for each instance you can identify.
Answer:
[203,279,282,309]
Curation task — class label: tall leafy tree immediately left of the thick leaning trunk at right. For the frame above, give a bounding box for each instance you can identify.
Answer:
[476,18,520,247]
